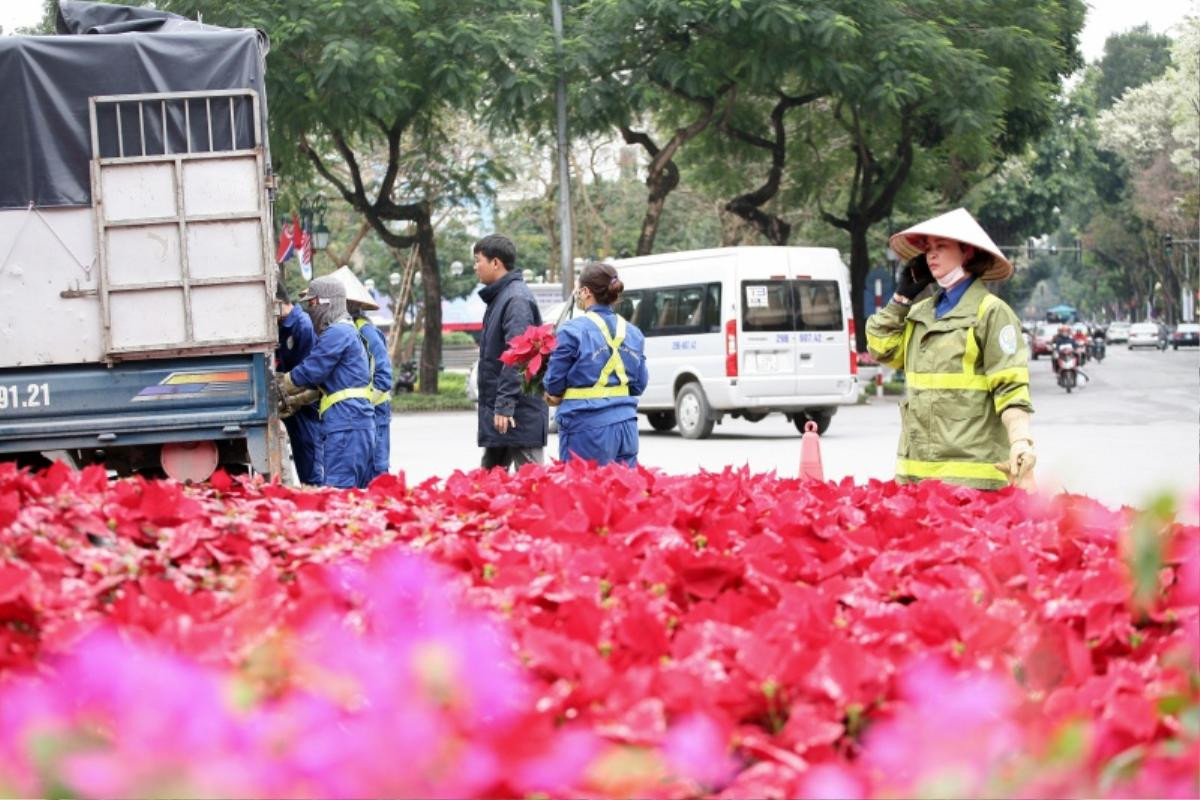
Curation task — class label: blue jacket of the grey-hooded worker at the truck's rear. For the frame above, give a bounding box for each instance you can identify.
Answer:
[292,320,374,434]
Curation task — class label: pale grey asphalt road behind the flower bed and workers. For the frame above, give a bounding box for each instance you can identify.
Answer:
[391,345,1200,522]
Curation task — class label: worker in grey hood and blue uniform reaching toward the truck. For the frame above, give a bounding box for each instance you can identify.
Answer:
[280,277,374,488]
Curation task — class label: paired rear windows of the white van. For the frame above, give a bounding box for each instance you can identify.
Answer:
[742,278,842,332]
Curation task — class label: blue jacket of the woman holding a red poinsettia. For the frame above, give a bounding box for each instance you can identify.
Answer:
[545,305,649,431]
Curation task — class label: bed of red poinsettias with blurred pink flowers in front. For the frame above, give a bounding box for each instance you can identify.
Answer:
[0,462,1200,796]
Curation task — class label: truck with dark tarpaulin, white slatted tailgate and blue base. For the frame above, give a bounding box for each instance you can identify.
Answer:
[0,0,286,481]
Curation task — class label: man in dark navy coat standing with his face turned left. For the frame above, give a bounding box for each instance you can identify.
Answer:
[474,234,550,469]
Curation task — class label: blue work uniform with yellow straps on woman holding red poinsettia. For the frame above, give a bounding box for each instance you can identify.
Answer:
[542,305,648,467]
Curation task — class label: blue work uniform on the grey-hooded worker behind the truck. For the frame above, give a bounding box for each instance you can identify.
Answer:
[290,319,374,488]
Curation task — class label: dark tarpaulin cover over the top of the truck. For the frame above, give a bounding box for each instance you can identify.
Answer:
[0,0,265,209]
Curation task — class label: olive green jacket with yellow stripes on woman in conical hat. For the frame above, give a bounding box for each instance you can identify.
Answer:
[866,279,1033,489]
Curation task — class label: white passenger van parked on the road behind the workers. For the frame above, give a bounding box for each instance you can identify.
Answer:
[592,247,858,439]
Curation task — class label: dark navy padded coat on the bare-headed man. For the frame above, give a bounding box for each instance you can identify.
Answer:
[478,270,550,447]
